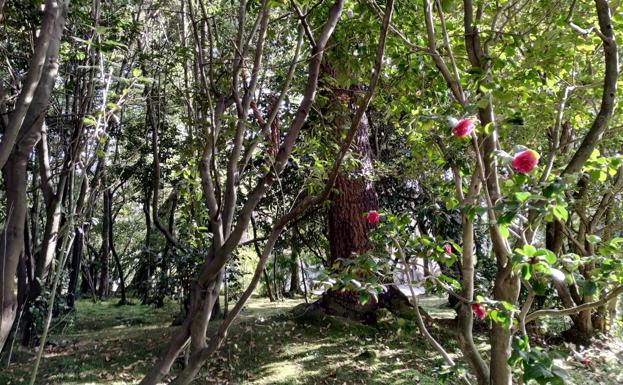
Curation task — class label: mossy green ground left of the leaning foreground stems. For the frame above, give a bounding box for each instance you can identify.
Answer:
[0,300,179,385]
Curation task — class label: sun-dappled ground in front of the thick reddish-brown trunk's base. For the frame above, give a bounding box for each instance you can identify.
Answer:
[190,308,452,385]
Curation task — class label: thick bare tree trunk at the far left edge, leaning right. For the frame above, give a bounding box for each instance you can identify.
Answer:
[0,0,67,347]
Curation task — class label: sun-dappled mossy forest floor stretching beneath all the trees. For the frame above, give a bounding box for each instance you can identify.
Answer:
[0,297,623,385]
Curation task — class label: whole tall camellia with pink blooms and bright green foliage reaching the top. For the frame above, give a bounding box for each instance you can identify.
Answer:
[352,0,623,385]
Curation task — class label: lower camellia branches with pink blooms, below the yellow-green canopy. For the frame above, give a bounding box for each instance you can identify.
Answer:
[360,109,623,384]
